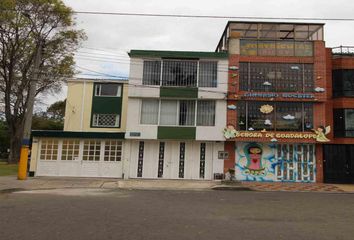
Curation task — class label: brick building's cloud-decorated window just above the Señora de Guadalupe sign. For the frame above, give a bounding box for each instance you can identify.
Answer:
[237,101,313,131]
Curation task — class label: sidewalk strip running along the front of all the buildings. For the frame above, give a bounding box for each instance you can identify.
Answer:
[0,176,354,193]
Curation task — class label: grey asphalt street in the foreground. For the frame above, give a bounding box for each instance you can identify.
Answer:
[0,189,354,240]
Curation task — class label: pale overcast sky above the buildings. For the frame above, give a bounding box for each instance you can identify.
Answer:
[38,0,354,109]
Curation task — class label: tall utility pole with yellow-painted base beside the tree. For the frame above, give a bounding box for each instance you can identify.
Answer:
[17,39,43,180]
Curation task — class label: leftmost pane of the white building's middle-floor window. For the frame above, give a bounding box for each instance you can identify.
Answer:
[140,99,159,125]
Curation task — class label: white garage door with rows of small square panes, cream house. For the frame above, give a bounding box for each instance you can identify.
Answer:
[36,139,122,178]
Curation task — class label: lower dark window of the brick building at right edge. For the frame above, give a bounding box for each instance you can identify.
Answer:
[333,109,354,137]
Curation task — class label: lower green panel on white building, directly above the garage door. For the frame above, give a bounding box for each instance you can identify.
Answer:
[157,127,196,139]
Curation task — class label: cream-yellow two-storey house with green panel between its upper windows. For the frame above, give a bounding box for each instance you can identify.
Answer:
[29,79,128,178]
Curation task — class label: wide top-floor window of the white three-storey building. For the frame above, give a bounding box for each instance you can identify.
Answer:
[143,60,218,87]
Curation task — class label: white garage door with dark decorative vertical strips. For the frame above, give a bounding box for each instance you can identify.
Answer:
[130,141,213,179]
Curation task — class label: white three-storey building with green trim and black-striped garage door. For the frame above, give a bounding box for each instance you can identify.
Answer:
[126,50,228,179]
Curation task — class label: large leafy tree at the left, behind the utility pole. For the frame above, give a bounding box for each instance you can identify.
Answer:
[0,0,85,162]
